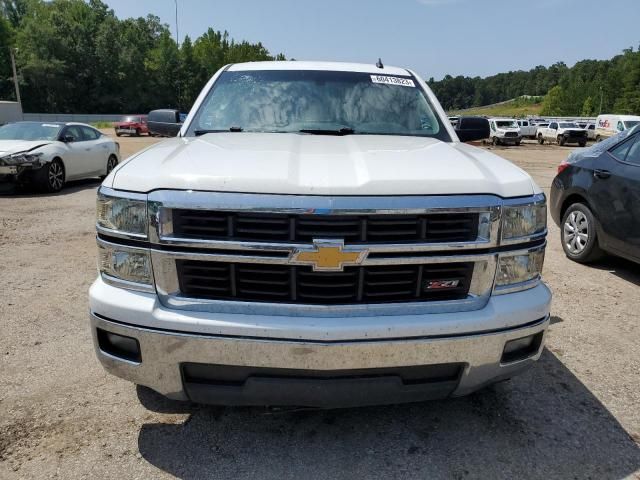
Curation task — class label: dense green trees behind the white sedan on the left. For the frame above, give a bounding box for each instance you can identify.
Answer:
[0,0,284,113]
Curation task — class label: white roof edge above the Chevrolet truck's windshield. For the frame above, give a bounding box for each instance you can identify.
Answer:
[228,60,410,75]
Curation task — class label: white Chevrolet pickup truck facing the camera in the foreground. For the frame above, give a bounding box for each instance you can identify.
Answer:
[89,62,551,407]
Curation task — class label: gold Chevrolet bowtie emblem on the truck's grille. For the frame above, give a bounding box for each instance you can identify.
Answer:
[289,239,369,272]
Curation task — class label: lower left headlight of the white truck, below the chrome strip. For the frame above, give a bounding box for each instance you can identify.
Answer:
[98,241,153,291]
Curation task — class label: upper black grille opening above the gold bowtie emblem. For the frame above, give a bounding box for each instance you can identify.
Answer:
[172,209,479,243]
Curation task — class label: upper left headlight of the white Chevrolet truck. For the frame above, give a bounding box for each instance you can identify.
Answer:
[97,191,148,238]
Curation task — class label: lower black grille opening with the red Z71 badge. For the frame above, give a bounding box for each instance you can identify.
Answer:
[176,260,474,305]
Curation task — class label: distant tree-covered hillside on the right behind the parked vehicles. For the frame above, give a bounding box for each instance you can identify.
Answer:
[428,48,640,116]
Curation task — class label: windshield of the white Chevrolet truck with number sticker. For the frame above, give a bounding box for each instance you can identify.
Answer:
[187,70,451,141]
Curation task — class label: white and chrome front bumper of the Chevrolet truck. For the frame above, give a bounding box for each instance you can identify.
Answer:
[90,279,551,407]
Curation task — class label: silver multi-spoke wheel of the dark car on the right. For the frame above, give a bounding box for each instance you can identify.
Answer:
[560,203,602,263]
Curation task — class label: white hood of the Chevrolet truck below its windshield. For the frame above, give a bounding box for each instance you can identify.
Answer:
[105,132,539,197]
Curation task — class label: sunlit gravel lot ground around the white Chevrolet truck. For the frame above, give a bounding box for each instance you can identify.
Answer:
[0,137,640,479]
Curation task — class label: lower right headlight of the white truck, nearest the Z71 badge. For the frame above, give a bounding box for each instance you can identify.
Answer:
[496,247,544,293]
